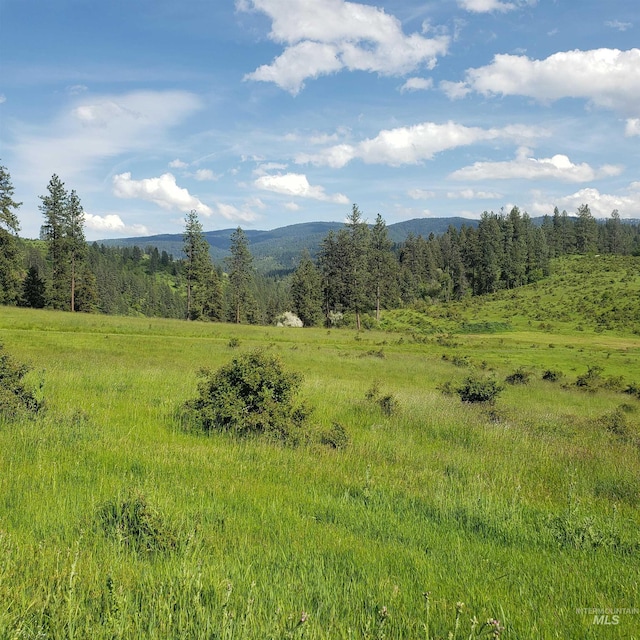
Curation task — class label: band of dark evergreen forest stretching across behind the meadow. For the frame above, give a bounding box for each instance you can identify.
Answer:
[0,167,640,328]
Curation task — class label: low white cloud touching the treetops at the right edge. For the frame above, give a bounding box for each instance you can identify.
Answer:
[530,185,640,218]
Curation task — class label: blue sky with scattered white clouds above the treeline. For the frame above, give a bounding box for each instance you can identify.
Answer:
[0,0,640,240]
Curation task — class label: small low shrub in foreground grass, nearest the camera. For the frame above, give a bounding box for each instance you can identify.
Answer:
[97,493,177,552]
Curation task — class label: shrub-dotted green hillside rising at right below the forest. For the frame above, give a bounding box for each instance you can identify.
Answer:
[382,255,640,335]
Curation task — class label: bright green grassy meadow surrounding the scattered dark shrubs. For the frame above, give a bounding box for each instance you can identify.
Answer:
[0,259,640,640]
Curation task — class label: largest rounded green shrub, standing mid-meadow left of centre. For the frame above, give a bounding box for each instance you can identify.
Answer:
[184,349,309,444]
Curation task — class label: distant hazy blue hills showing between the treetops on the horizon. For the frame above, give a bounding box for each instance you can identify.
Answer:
[97,218,478,273]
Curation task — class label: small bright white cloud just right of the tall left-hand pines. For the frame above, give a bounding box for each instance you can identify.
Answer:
[113,172,213,216]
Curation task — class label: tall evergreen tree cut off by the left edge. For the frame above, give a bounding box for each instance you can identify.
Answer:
[0,166,22,304]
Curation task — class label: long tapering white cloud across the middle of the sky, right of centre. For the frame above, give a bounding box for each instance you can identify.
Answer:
[296,122,546,168]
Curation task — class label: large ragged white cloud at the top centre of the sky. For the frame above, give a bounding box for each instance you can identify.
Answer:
[236,0,449,95]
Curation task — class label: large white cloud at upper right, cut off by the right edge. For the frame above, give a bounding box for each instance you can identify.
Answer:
[466,49,640,114]
